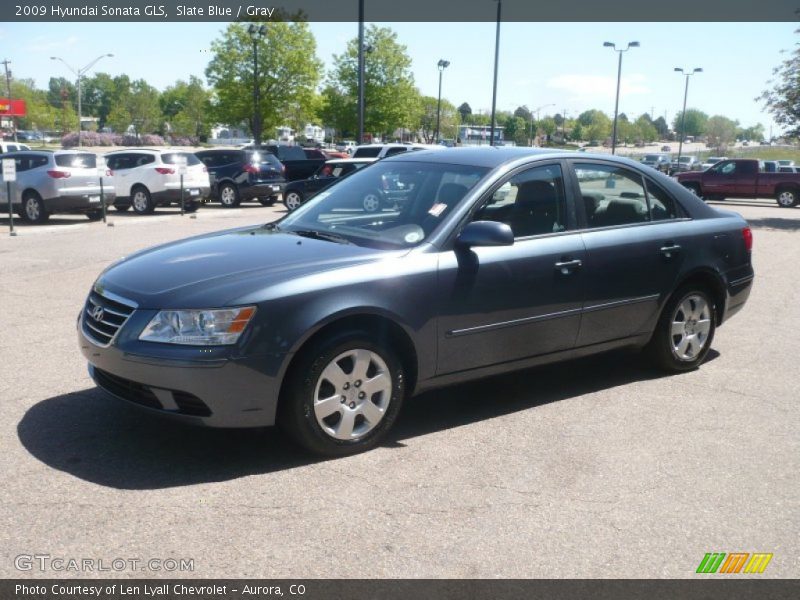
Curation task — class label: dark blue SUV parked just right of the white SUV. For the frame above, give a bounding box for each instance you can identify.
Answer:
[195,149,286,208]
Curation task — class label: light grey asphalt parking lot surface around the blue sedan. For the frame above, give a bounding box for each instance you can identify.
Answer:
[0,201,800,578]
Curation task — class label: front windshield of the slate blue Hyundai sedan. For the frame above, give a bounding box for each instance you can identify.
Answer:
[277,161,489,249]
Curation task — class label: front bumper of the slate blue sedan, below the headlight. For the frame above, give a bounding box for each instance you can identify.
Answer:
[77,311,287,427]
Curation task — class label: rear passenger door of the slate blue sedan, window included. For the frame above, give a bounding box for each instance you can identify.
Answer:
[571,160,691,347]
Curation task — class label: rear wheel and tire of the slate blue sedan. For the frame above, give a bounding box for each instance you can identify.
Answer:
[646,284,717,373]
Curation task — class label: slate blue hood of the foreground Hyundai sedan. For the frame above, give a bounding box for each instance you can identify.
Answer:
[95,227,396,309]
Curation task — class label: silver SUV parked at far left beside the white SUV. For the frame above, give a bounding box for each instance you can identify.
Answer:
[3,150,115,223]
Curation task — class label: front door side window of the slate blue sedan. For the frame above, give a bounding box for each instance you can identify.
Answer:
[473,165,567,238]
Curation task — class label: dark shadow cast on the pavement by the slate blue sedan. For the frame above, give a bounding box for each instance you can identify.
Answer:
[17,350,718,490]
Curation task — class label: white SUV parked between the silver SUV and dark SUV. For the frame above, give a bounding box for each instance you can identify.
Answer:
[105,148,211,215]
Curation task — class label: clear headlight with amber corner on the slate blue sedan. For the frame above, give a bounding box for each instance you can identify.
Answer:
[139,306,256,346]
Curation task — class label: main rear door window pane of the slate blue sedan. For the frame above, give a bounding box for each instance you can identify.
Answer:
[575,163,649,228]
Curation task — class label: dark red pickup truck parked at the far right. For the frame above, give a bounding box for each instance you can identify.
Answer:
[675,159,800,208]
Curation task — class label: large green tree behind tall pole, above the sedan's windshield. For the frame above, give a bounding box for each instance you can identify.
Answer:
[323,25,421,141]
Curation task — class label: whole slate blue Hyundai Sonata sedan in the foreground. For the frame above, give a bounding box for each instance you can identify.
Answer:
[78,147,753,455]
